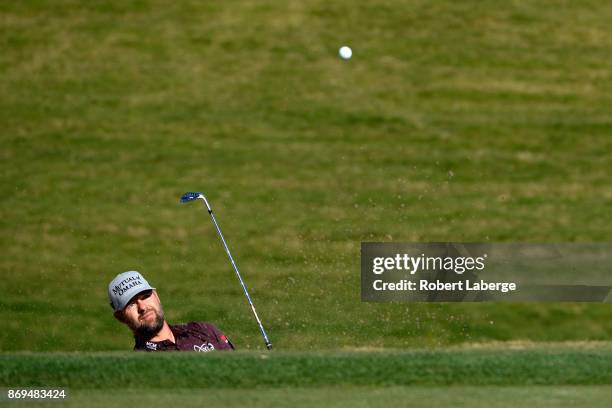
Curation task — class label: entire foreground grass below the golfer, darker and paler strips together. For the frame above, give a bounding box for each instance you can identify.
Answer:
[0,345,612,407]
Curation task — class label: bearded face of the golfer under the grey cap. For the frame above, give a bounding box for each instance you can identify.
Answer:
[118,290,164,338]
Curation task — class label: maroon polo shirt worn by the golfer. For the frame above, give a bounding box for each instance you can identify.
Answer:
[134,322,234,352]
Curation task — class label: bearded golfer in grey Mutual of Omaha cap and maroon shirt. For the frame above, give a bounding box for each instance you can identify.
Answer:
[108,271,234,352]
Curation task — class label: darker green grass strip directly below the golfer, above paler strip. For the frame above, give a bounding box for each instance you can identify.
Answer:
[0,350,612,389]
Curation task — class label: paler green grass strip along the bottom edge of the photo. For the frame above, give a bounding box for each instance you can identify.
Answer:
[7,386,612,408]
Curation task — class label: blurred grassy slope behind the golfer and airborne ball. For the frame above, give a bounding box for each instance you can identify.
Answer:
[0,0,612,351]
